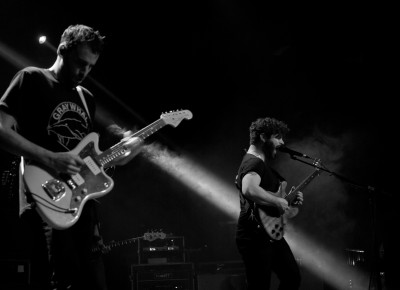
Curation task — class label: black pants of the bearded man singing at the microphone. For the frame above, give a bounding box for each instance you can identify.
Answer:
[236,230,301,290]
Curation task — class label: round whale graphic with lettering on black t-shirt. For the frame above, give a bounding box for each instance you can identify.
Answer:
[47,102,89,150]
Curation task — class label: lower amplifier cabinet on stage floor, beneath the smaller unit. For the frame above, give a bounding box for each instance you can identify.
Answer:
[131,263,194,290]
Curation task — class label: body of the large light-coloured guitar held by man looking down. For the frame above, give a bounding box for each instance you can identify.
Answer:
[24,133,114,229]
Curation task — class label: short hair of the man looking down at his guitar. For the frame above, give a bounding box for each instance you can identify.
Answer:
[60,24,105,54]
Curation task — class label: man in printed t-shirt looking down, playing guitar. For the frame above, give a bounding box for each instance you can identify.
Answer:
[0,25,142,290]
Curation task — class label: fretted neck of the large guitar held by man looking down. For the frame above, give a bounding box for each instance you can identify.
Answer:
[97,119,167,168]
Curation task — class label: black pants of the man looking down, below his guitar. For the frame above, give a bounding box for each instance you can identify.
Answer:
[22,203,107,290]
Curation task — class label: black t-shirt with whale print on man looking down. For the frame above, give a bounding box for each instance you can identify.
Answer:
[0,67,95,152]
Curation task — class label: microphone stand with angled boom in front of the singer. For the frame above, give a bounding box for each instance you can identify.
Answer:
[289,153,390,290]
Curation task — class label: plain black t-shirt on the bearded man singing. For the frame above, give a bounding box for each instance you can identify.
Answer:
[235,154,284,239]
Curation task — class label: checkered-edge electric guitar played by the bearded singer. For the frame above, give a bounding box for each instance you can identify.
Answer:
[256,160,321,240]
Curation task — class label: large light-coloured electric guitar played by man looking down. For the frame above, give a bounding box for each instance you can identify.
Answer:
[23,110,193,229]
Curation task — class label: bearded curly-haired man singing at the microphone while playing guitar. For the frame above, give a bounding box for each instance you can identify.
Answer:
[236,117,303,290]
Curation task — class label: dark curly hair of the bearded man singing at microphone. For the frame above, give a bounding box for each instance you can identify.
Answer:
[249,117,290,145]
